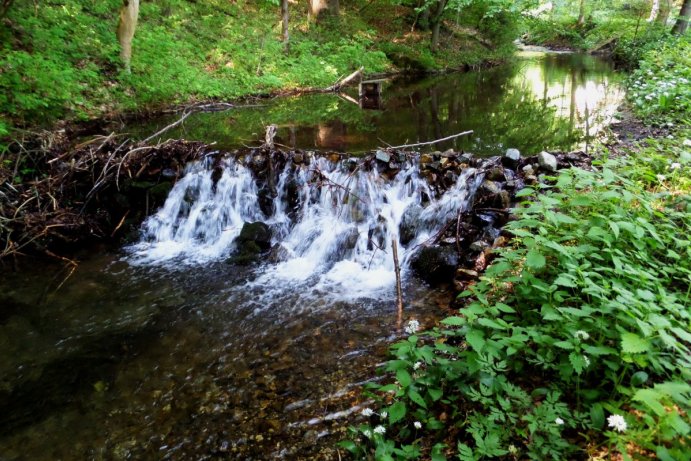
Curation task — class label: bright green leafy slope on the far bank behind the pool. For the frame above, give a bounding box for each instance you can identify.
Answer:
[0,0,532,137]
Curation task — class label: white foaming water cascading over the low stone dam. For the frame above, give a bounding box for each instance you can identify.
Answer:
[129,151,482,299]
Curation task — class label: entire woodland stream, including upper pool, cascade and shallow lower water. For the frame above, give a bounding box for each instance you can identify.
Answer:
[0,53,623,461]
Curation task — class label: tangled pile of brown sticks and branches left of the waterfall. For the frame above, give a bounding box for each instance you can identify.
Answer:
[0,133,206,258]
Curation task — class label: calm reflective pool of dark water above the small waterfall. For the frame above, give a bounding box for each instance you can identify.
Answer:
[132,53,623,155]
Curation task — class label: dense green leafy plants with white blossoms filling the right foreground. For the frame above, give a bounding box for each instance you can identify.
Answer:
[342,149,691,460]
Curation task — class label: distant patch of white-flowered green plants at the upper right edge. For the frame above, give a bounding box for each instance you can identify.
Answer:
[629,35,691,122]
